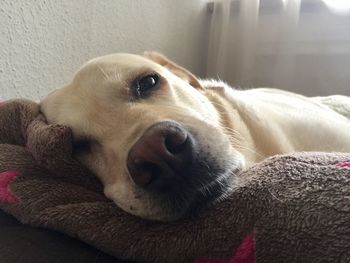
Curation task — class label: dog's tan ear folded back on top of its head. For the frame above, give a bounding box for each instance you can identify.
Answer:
[143,51,204,89]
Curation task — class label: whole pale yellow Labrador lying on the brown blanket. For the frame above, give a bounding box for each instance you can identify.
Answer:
[40,52,350,221]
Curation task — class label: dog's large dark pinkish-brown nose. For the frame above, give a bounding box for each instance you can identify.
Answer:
[127,121,194,189]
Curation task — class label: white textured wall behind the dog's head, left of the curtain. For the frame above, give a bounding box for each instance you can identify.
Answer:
[0,0,207,99]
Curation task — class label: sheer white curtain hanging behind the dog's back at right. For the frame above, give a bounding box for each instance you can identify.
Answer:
[207,0,350,95]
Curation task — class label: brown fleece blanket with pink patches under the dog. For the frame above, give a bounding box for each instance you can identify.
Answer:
[0,100,350,263]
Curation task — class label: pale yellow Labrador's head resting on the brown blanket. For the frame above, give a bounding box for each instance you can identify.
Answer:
[41,53,242,220]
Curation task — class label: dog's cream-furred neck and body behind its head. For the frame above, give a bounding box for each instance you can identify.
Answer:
[203,81,350,165]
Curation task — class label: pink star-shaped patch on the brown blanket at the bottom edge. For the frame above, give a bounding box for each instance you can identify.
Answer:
[195,234,255,263]
